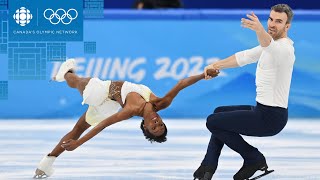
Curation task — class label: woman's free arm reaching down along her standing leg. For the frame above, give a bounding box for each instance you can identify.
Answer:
[61,109,132,151]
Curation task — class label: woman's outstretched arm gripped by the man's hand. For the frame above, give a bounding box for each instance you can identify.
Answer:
[152,69,219,110]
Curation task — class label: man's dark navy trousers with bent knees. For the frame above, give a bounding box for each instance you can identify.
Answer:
[201,103,288,167]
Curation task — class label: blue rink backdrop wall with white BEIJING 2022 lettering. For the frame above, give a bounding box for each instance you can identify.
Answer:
[0,10,320,118]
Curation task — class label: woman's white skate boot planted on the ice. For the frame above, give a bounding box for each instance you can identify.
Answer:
[33,155,57,179]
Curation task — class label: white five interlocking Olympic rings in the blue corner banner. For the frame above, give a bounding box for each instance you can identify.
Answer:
[43,8,78,25]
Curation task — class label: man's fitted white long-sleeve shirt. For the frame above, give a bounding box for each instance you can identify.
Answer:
[235,38,295,108]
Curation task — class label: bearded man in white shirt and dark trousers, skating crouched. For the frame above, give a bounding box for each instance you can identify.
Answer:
[193,4,295,180]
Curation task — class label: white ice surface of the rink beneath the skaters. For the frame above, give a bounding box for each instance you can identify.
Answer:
[0,119,320,180]
